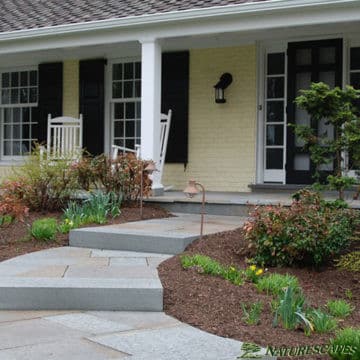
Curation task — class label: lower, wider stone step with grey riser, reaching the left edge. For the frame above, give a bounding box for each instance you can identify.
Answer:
[0,247,170,311]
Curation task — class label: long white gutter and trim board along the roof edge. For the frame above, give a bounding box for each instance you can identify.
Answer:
[0,0,360,54]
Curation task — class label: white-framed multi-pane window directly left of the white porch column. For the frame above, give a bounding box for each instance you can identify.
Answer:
[110,59,141,149]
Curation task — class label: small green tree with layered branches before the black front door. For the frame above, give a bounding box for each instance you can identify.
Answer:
[292,82,360,199]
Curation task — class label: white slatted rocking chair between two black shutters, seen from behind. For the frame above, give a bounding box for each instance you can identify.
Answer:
[40,114,83,161]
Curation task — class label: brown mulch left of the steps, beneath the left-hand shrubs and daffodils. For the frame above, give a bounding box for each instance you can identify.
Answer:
[0,204,171,261]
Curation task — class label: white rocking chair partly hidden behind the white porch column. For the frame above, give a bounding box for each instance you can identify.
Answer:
[112,110,172,181]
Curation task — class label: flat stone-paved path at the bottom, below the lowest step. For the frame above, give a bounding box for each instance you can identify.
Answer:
[0,311,246,360]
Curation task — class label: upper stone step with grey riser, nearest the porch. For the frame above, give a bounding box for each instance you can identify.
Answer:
[70,214,245,254]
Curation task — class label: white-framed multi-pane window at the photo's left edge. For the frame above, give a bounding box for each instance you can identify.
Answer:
[0,68,38,160]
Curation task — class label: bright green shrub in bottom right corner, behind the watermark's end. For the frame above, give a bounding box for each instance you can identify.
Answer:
[329,328,360,360]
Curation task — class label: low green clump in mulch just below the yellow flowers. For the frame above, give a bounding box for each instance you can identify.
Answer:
[255,274,299,295]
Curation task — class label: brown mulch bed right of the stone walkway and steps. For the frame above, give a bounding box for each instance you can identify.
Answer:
[159,229,360,359]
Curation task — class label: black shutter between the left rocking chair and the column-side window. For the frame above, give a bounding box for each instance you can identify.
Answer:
[80,59,106,155]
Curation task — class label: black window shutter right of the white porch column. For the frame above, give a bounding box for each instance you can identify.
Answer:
[161,51,189,164]
